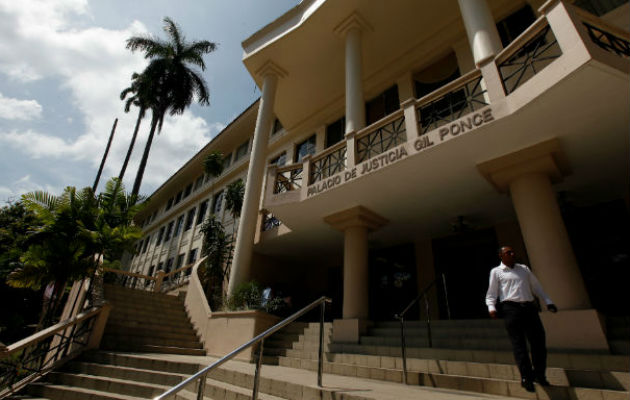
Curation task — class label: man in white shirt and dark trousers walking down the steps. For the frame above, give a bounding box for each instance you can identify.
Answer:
[486,246,558,392]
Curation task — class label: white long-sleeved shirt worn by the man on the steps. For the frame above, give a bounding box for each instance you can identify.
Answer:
[486,263,553,311]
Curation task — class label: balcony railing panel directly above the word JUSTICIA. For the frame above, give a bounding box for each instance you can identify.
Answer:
[356,110,407,163]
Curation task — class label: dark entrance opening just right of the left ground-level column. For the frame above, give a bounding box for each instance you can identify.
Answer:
[369,244,418,321]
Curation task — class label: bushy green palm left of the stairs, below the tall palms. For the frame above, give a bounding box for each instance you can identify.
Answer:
[7,178,142,326]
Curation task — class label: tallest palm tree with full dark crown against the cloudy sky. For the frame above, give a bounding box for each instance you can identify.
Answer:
[127,17,216,195]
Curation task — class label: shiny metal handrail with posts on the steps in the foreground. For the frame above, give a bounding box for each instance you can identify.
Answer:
[153,296,332,400]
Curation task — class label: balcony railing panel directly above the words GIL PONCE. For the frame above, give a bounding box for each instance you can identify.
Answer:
[416,70,488,135]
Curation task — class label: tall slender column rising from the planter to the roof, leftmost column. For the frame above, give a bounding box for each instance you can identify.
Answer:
[228,62,284,296]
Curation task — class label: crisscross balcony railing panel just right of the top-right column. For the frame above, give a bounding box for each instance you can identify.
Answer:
[496,18,562,95]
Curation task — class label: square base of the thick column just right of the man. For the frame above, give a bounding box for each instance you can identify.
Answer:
[540,308,610,353]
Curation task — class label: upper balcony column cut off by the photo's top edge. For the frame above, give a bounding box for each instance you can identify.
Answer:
[458,0,502,66]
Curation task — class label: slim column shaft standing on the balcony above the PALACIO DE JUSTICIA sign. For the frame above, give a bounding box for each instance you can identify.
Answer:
[346,26,365,132]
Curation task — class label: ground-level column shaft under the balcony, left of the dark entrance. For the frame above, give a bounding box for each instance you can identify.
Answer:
[342,226,369,319]
